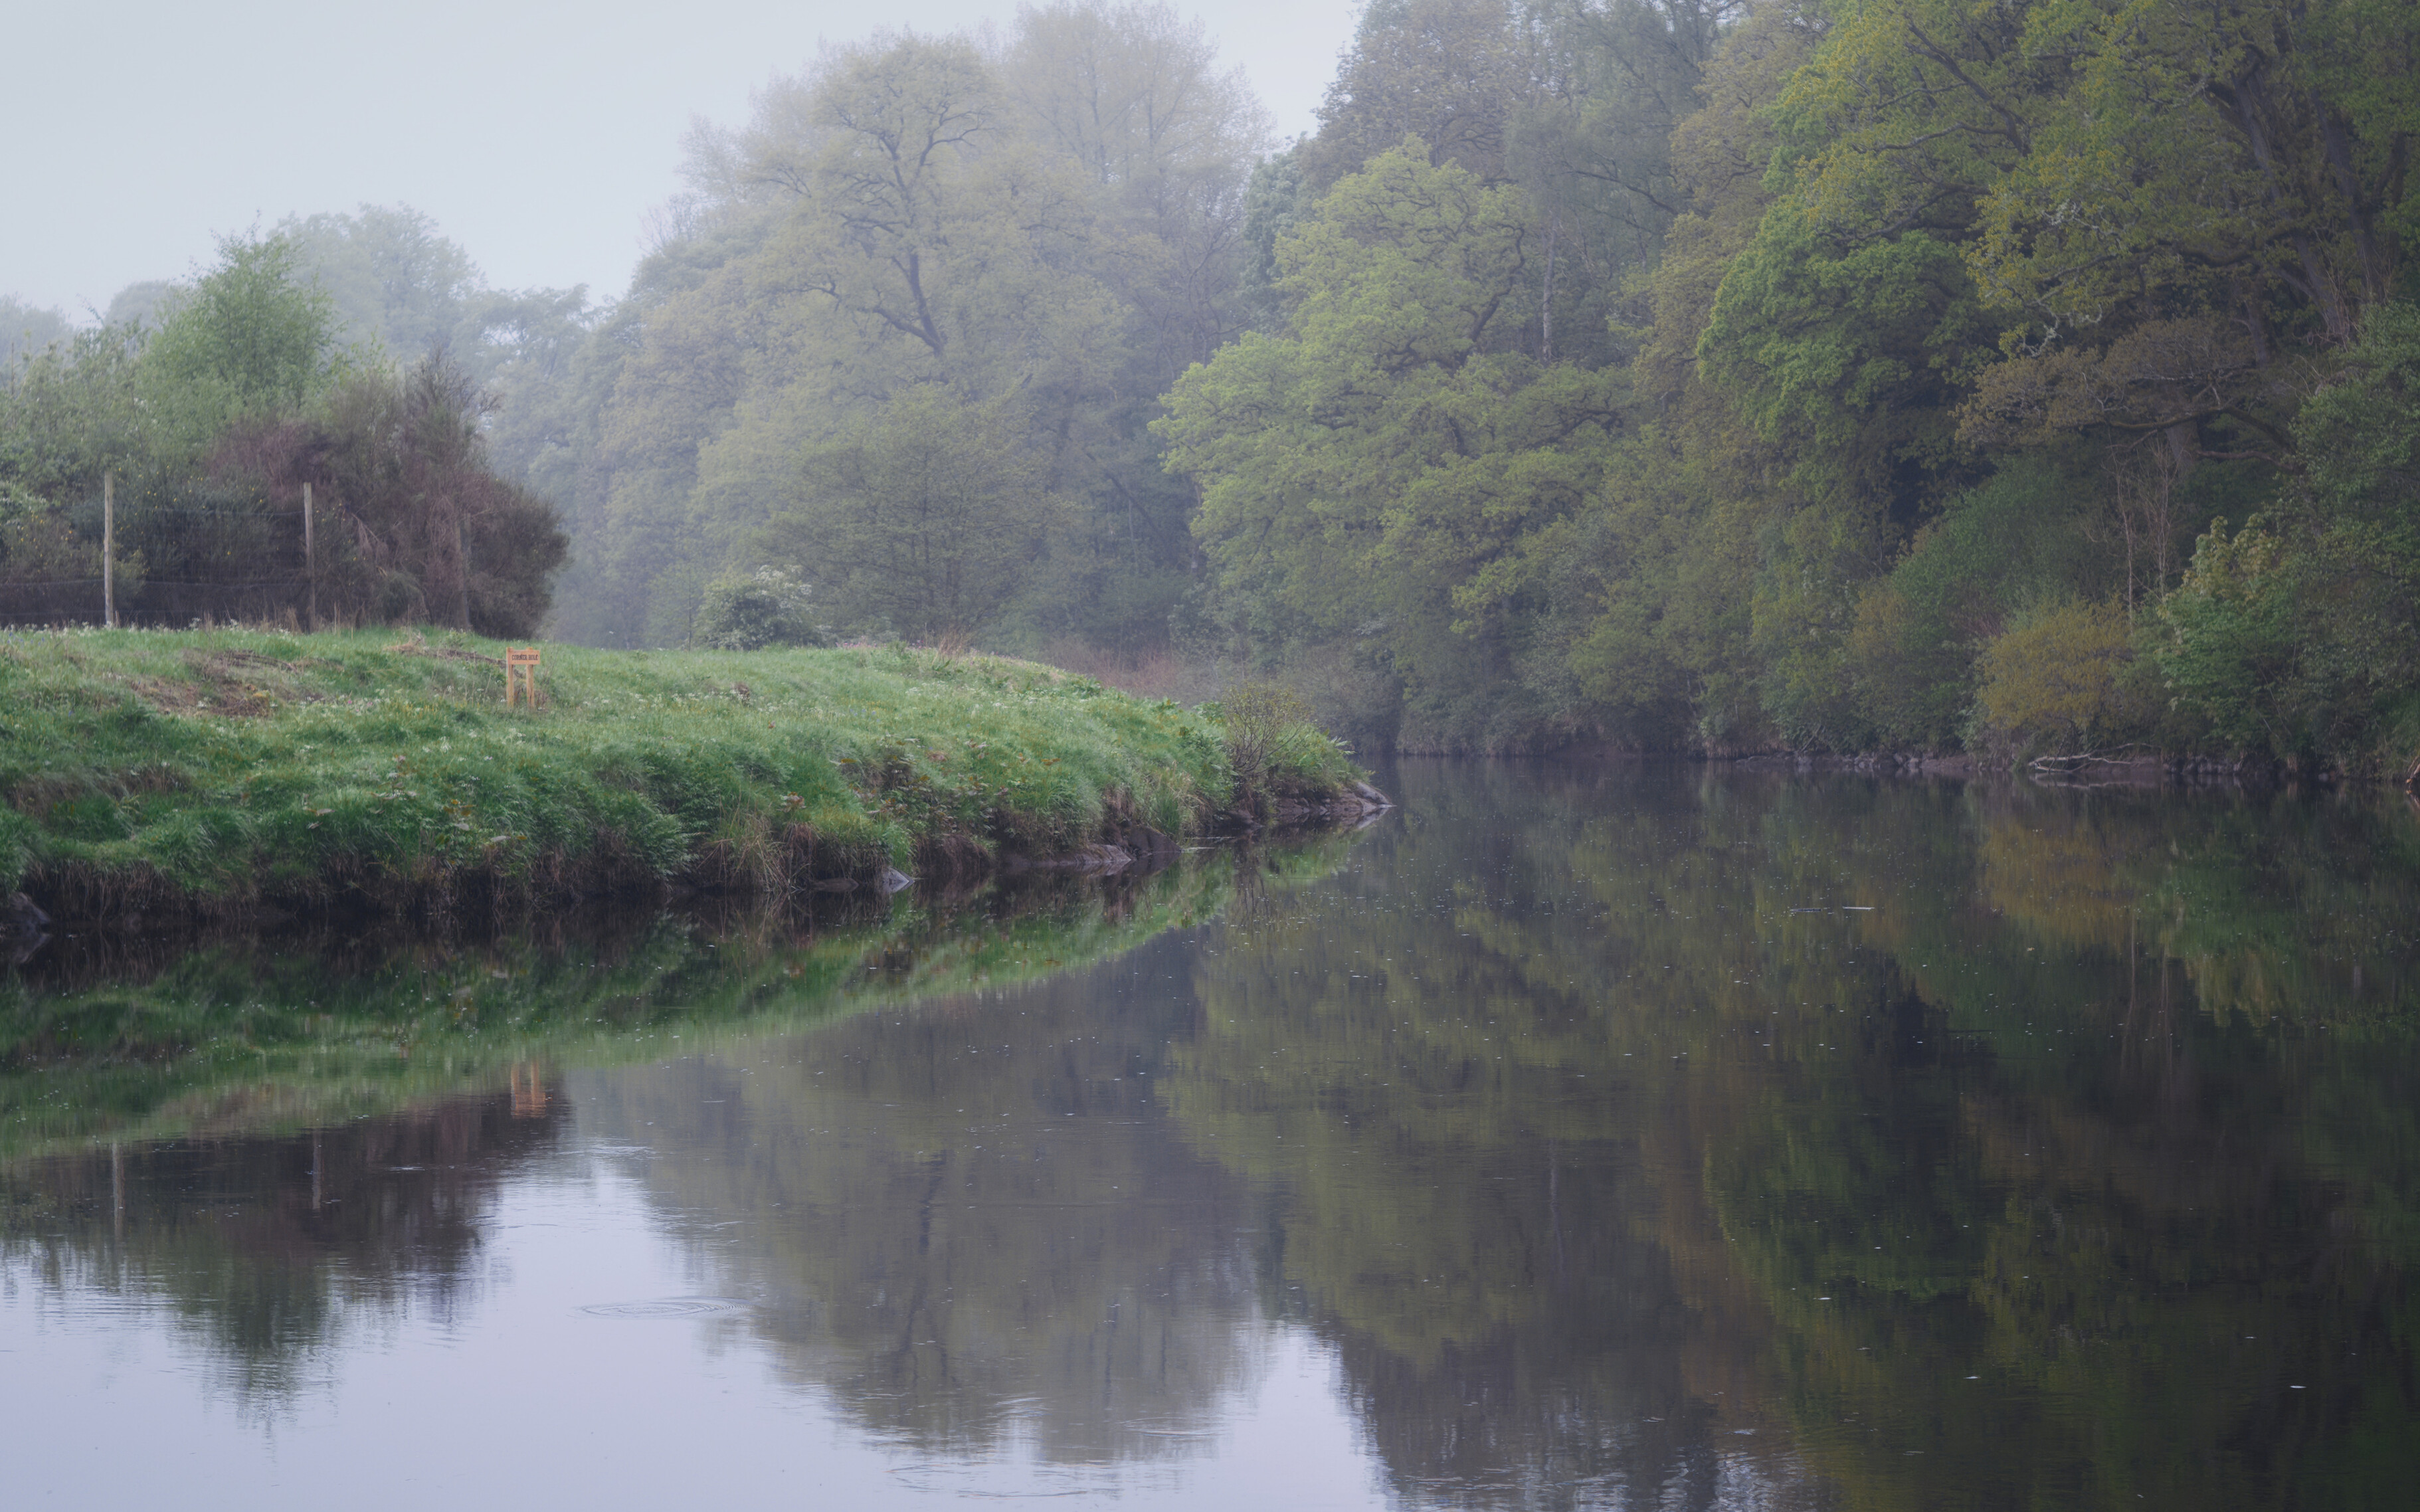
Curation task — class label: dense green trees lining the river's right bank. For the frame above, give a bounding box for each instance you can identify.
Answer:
[1159,0,2420,762]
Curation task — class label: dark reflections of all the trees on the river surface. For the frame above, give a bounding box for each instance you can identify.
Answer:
[10,762,2420,1507]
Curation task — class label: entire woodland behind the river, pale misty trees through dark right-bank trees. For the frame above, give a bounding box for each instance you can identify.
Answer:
[0,0,2420,774]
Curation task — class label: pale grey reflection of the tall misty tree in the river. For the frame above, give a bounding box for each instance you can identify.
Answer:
[583,941,1256,1464]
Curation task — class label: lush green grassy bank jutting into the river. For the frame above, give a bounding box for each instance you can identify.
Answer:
[0,629,1358,917]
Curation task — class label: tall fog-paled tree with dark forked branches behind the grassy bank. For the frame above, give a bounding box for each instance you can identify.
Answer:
[559,5,1263,646]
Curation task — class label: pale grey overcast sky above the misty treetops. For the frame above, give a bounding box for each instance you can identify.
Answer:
[0,0,1358,322]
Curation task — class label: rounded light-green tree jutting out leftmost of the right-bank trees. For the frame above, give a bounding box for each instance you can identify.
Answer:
[1155,140,1622,740]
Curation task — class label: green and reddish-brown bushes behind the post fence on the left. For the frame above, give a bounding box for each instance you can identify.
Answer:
[0,233,569,636]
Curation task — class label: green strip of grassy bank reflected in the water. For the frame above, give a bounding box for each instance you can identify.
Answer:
[0,837,1287,1161]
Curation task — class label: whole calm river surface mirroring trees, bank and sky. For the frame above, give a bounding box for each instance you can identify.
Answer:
[0,762,2420,1509]
